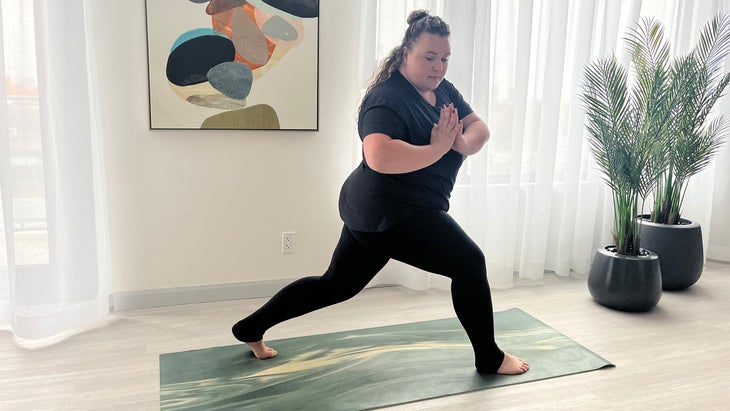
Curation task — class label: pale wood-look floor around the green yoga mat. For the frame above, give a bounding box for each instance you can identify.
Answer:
[0,262,730,411]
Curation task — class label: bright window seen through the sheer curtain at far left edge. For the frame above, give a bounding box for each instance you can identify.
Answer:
[0,0,49,266]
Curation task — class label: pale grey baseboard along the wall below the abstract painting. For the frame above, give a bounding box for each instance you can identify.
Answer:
[111,278,294,311]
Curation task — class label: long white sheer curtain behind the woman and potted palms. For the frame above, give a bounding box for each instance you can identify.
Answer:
[362,0,730,288]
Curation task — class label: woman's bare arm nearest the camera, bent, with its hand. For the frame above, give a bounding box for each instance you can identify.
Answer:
[363,105,463,174]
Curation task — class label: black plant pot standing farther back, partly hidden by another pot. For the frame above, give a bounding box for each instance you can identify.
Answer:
[641,215,705,290]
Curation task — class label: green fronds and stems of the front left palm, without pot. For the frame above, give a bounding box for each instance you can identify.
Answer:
[580,19,671,256]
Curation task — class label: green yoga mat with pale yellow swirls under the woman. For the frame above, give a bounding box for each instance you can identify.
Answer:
[160,308,613,411]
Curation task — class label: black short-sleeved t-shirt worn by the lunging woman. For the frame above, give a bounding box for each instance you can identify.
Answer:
[339,70,473,232]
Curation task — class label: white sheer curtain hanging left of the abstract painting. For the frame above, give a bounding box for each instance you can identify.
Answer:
[0,0,109,339]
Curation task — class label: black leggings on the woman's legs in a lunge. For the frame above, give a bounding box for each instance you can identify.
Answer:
[233,211,504,373]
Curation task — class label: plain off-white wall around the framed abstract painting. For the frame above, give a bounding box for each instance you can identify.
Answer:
[92,0,360,292]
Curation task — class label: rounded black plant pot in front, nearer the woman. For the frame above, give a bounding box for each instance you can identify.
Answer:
[588,246,662,312]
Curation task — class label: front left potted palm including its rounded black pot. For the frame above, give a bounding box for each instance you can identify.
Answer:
[580,19,669,311]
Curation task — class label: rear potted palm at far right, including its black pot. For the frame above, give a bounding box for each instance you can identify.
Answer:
[631,14,730,290]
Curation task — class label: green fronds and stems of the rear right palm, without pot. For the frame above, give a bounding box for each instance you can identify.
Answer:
[629,14,730,224]
